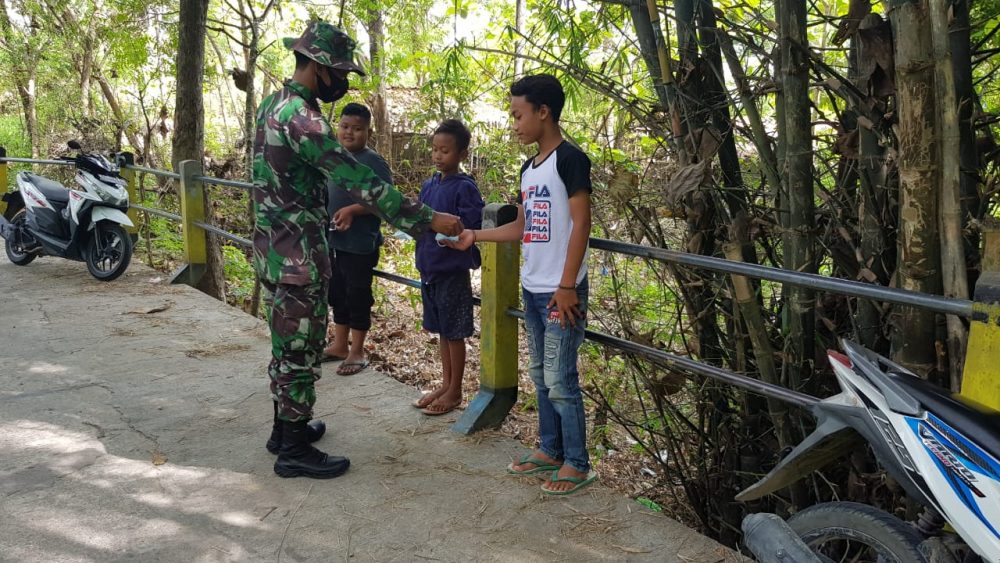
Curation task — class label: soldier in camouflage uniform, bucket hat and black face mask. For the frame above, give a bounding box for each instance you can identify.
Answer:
[253,22,462,478]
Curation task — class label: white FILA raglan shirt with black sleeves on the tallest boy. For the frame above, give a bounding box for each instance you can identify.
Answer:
[518,141,593,293]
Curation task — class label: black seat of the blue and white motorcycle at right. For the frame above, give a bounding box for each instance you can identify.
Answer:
[892,373,1000,460]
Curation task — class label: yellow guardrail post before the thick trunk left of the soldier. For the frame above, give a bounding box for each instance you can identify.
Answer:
[170,160,208,287]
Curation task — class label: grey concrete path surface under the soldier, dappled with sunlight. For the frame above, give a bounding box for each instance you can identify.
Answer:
[0,252,739,563]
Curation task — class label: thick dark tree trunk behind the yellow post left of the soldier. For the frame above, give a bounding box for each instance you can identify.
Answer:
[172,0,226,300]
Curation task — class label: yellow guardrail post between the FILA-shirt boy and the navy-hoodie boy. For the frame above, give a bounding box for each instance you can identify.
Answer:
[451,203,521,434]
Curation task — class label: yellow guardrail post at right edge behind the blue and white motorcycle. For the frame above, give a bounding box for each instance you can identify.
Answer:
[962,229,1000,410]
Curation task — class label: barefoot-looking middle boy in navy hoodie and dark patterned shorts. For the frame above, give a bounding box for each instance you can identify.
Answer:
[413,119,484,416]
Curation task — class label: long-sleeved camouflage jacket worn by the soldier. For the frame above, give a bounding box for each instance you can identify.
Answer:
[253,81,434,285]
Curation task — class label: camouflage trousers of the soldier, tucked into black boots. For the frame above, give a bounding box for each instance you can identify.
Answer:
[261,281,327,422]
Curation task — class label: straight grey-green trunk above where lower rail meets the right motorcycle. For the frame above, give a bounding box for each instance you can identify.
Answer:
[777,0,816,389]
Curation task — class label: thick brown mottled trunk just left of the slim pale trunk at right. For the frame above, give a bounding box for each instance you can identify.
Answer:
[889,0,941,376]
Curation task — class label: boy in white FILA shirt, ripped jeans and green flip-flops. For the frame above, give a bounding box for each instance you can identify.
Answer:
[451,74,597,495]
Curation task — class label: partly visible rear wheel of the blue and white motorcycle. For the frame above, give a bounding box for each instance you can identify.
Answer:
[788,502,928,563]
